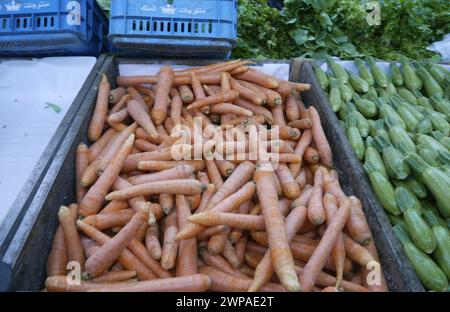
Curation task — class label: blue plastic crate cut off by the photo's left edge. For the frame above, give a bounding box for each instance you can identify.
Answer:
[0,0,110,56]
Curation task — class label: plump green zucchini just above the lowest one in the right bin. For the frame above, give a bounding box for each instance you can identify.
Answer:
[403,205,436,254]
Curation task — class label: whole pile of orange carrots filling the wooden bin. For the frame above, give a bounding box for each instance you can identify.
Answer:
[45,60,387,292]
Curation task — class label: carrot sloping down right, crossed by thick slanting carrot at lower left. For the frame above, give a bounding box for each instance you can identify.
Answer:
[77,220,156,280]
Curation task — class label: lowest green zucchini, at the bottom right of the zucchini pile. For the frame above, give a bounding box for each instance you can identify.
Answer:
[394,225,448,291]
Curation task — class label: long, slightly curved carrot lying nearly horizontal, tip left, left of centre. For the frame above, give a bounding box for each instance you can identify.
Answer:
[105,179,206,200]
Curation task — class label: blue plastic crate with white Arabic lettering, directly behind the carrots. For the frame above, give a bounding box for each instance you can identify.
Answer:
[108,0,237,58]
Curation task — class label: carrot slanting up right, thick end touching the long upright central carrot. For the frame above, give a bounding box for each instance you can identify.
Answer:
[207,162,256,209]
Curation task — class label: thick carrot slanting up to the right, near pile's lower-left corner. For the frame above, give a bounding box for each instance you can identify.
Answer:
[86,212,146,277]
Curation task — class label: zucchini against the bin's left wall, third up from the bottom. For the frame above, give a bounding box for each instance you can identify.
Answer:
[364,162,401,216]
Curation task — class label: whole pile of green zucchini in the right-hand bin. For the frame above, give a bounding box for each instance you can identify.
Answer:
[315,57,450,291]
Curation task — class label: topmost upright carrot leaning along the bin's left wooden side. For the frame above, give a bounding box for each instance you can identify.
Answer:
[88,74,111,142]
